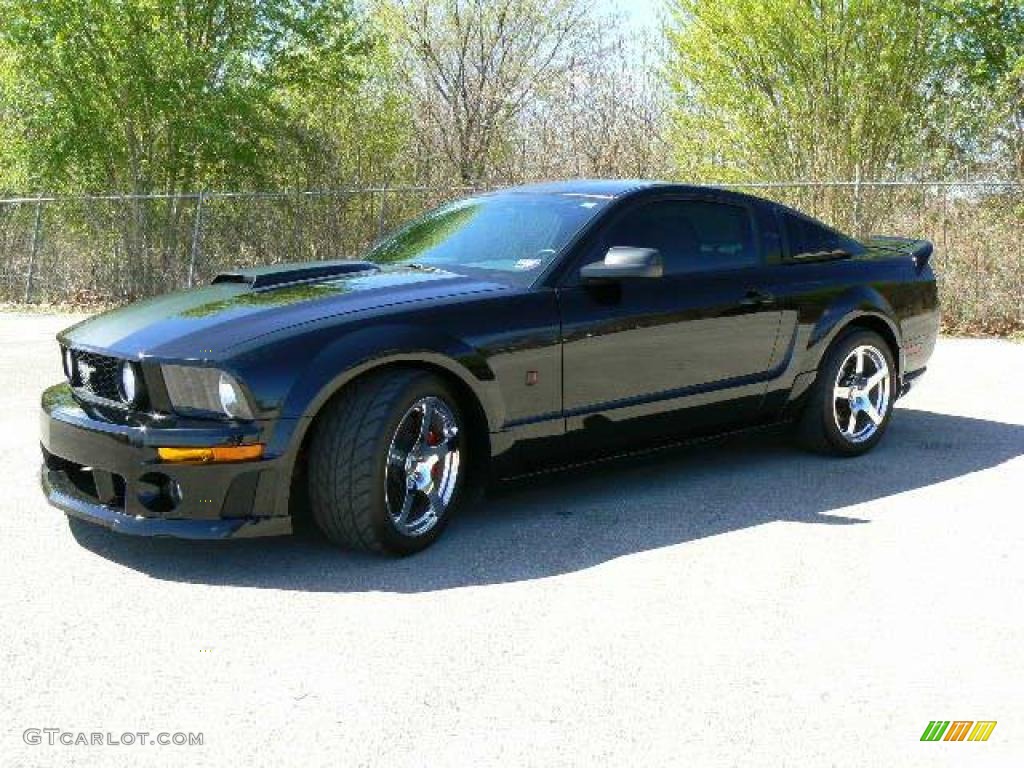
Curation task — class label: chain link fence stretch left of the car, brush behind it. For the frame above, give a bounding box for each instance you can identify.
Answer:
[0,186,479,303]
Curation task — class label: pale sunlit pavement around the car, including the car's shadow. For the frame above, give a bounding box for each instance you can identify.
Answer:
[0,313,1024,768]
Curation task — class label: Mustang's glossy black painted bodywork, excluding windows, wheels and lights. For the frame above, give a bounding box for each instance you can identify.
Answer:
[42,181,938,538]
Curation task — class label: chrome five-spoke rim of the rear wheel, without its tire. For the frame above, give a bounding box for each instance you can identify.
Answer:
[833,345,892,442]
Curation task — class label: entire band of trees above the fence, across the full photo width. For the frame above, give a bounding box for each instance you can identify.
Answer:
[0,0,1024,195]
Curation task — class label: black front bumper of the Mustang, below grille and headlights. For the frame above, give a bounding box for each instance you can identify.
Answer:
[40,384,292,539]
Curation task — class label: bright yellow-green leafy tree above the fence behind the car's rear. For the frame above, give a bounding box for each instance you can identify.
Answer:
[668,0,939,181]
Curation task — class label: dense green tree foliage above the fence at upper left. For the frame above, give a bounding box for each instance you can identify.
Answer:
[0,0,371,193]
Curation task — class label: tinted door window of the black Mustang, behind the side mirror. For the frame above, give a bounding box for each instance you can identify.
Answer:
[604,200,758,274]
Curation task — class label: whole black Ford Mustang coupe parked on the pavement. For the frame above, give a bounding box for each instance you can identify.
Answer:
[42,181,939,554]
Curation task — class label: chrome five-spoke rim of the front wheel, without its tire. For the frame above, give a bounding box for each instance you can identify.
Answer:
[384,396,459,537]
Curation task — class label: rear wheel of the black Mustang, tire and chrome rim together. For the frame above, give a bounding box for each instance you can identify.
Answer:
[799,331,896,457]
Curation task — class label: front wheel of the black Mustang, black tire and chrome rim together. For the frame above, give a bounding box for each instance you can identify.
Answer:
[308,370,467,555]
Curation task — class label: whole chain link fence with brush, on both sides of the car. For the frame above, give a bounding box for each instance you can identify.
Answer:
[0,181,1024,333]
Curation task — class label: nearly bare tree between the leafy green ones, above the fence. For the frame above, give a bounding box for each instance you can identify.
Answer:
[387,0,588,184]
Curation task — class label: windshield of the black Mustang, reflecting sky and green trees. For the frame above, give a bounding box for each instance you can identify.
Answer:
[367,193,608,285]
